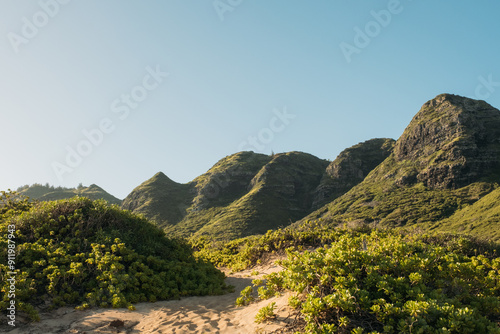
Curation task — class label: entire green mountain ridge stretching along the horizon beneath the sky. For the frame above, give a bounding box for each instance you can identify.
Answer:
[9,94,500,240]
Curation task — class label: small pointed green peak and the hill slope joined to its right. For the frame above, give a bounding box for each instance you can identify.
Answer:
[122,152,271,237]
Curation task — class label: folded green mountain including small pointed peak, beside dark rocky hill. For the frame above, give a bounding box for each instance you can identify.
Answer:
[122,152,328,239]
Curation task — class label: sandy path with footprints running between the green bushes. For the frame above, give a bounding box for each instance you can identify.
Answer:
[3,261,290,334]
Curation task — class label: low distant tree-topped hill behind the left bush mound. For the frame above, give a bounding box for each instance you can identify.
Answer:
[17,184,122,205]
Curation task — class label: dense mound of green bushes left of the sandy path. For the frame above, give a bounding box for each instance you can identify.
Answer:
[0,192,226,319]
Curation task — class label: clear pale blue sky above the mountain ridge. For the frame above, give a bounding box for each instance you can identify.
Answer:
[0,0,500,198]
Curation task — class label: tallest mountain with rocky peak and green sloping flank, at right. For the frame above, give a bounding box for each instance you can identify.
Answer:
[294,94,500,240]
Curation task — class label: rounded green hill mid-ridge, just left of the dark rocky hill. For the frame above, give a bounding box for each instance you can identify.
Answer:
[182,152,328,239]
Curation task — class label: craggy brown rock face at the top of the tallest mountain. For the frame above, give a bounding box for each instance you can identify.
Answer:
[394,94,500,189]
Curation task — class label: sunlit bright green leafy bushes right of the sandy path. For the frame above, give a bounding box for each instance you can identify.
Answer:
[229,225,500,334]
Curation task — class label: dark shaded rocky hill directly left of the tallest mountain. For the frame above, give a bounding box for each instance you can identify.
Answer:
[313,138,396,209]
